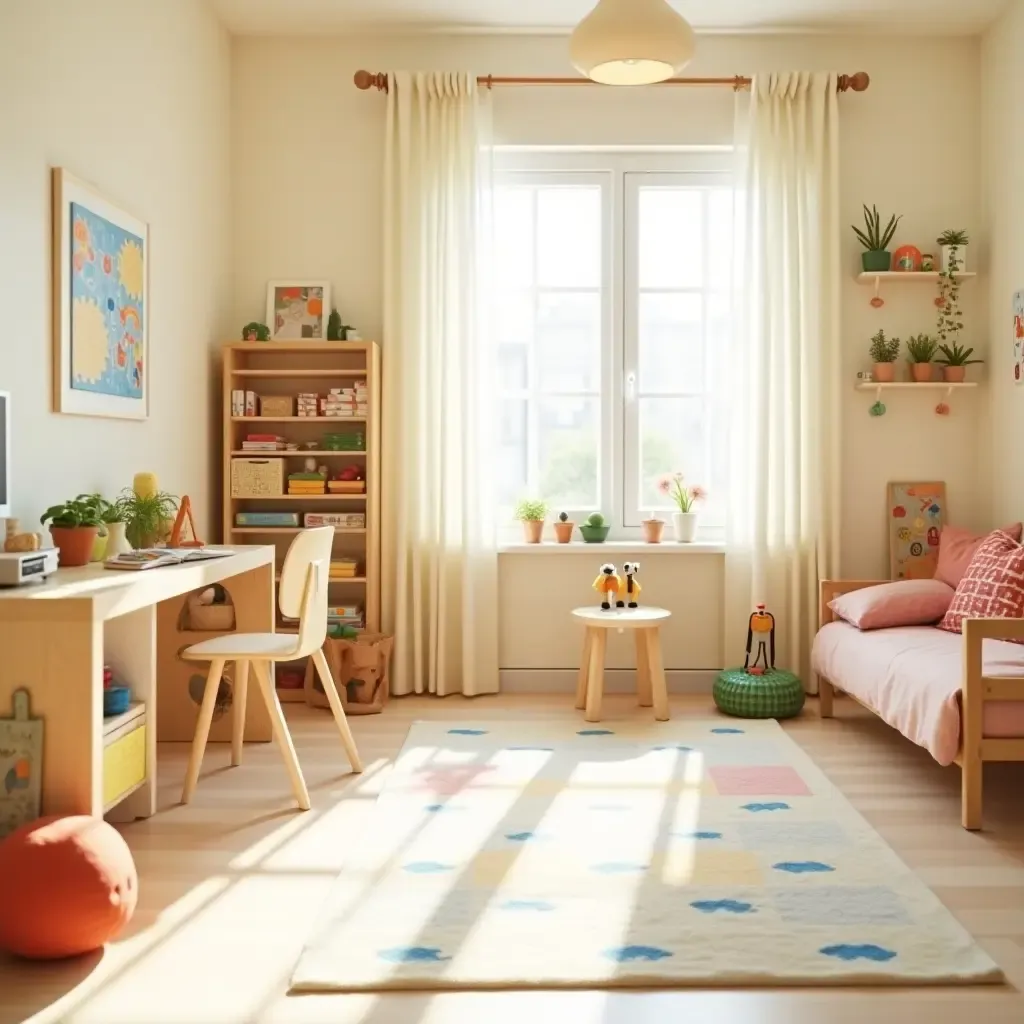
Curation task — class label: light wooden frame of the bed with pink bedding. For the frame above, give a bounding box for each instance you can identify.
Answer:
[818,580,1024,830]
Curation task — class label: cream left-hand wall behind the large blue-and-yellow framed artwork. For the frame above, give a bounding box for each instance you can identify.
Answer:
[0,0,230,528]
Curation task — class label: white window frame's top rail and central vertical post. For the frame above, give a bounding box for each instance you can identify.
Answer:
[495,145,733,541]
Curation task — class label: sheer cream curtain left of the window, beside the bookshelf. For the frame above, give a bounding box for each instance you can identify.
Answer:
[382,72,498,696]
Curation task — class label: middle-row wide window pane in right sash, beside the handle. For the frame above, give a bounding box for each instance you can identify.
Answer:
[639,292,705,392]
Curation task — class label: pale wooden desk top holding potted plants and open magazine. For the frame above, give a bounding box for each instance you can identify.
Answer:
[0,544,275,620]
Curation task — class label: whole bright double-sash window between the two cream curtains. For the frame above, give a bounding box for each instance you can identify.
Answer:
[495,153,732,537]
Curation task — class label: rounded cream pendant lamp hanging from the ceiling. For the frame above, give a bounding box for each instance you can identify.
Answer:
[569,0,696,85]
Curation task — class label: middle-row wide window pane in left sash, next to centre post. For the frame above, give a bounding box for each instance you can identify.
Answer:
[536,292,601,392]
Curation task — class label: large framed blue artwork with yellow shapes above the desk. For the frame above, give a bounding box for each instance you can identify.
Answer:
[52,167,150,420]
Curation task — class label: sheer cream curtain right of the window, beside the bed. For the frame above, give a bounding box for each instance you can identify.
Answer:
[725,72,841,685]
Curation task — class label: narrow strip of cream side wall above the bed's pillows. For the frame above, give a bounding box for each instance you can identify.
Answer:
[981,3,1024,522]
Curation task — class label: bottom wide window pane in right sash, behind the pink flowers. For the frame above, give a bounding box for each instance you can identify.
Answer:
[639,398,711,512]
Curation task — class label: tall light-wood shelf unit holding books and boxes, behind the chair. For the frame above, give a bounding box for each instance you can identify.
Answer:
[222,341,381,651]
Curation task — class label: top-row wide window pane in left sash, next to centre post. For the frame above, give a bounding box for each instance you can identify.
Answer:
[537,185,601,288]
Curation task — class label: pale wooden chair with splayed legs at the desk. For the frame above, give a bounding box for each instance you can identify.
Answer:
[181,526,362,811]
